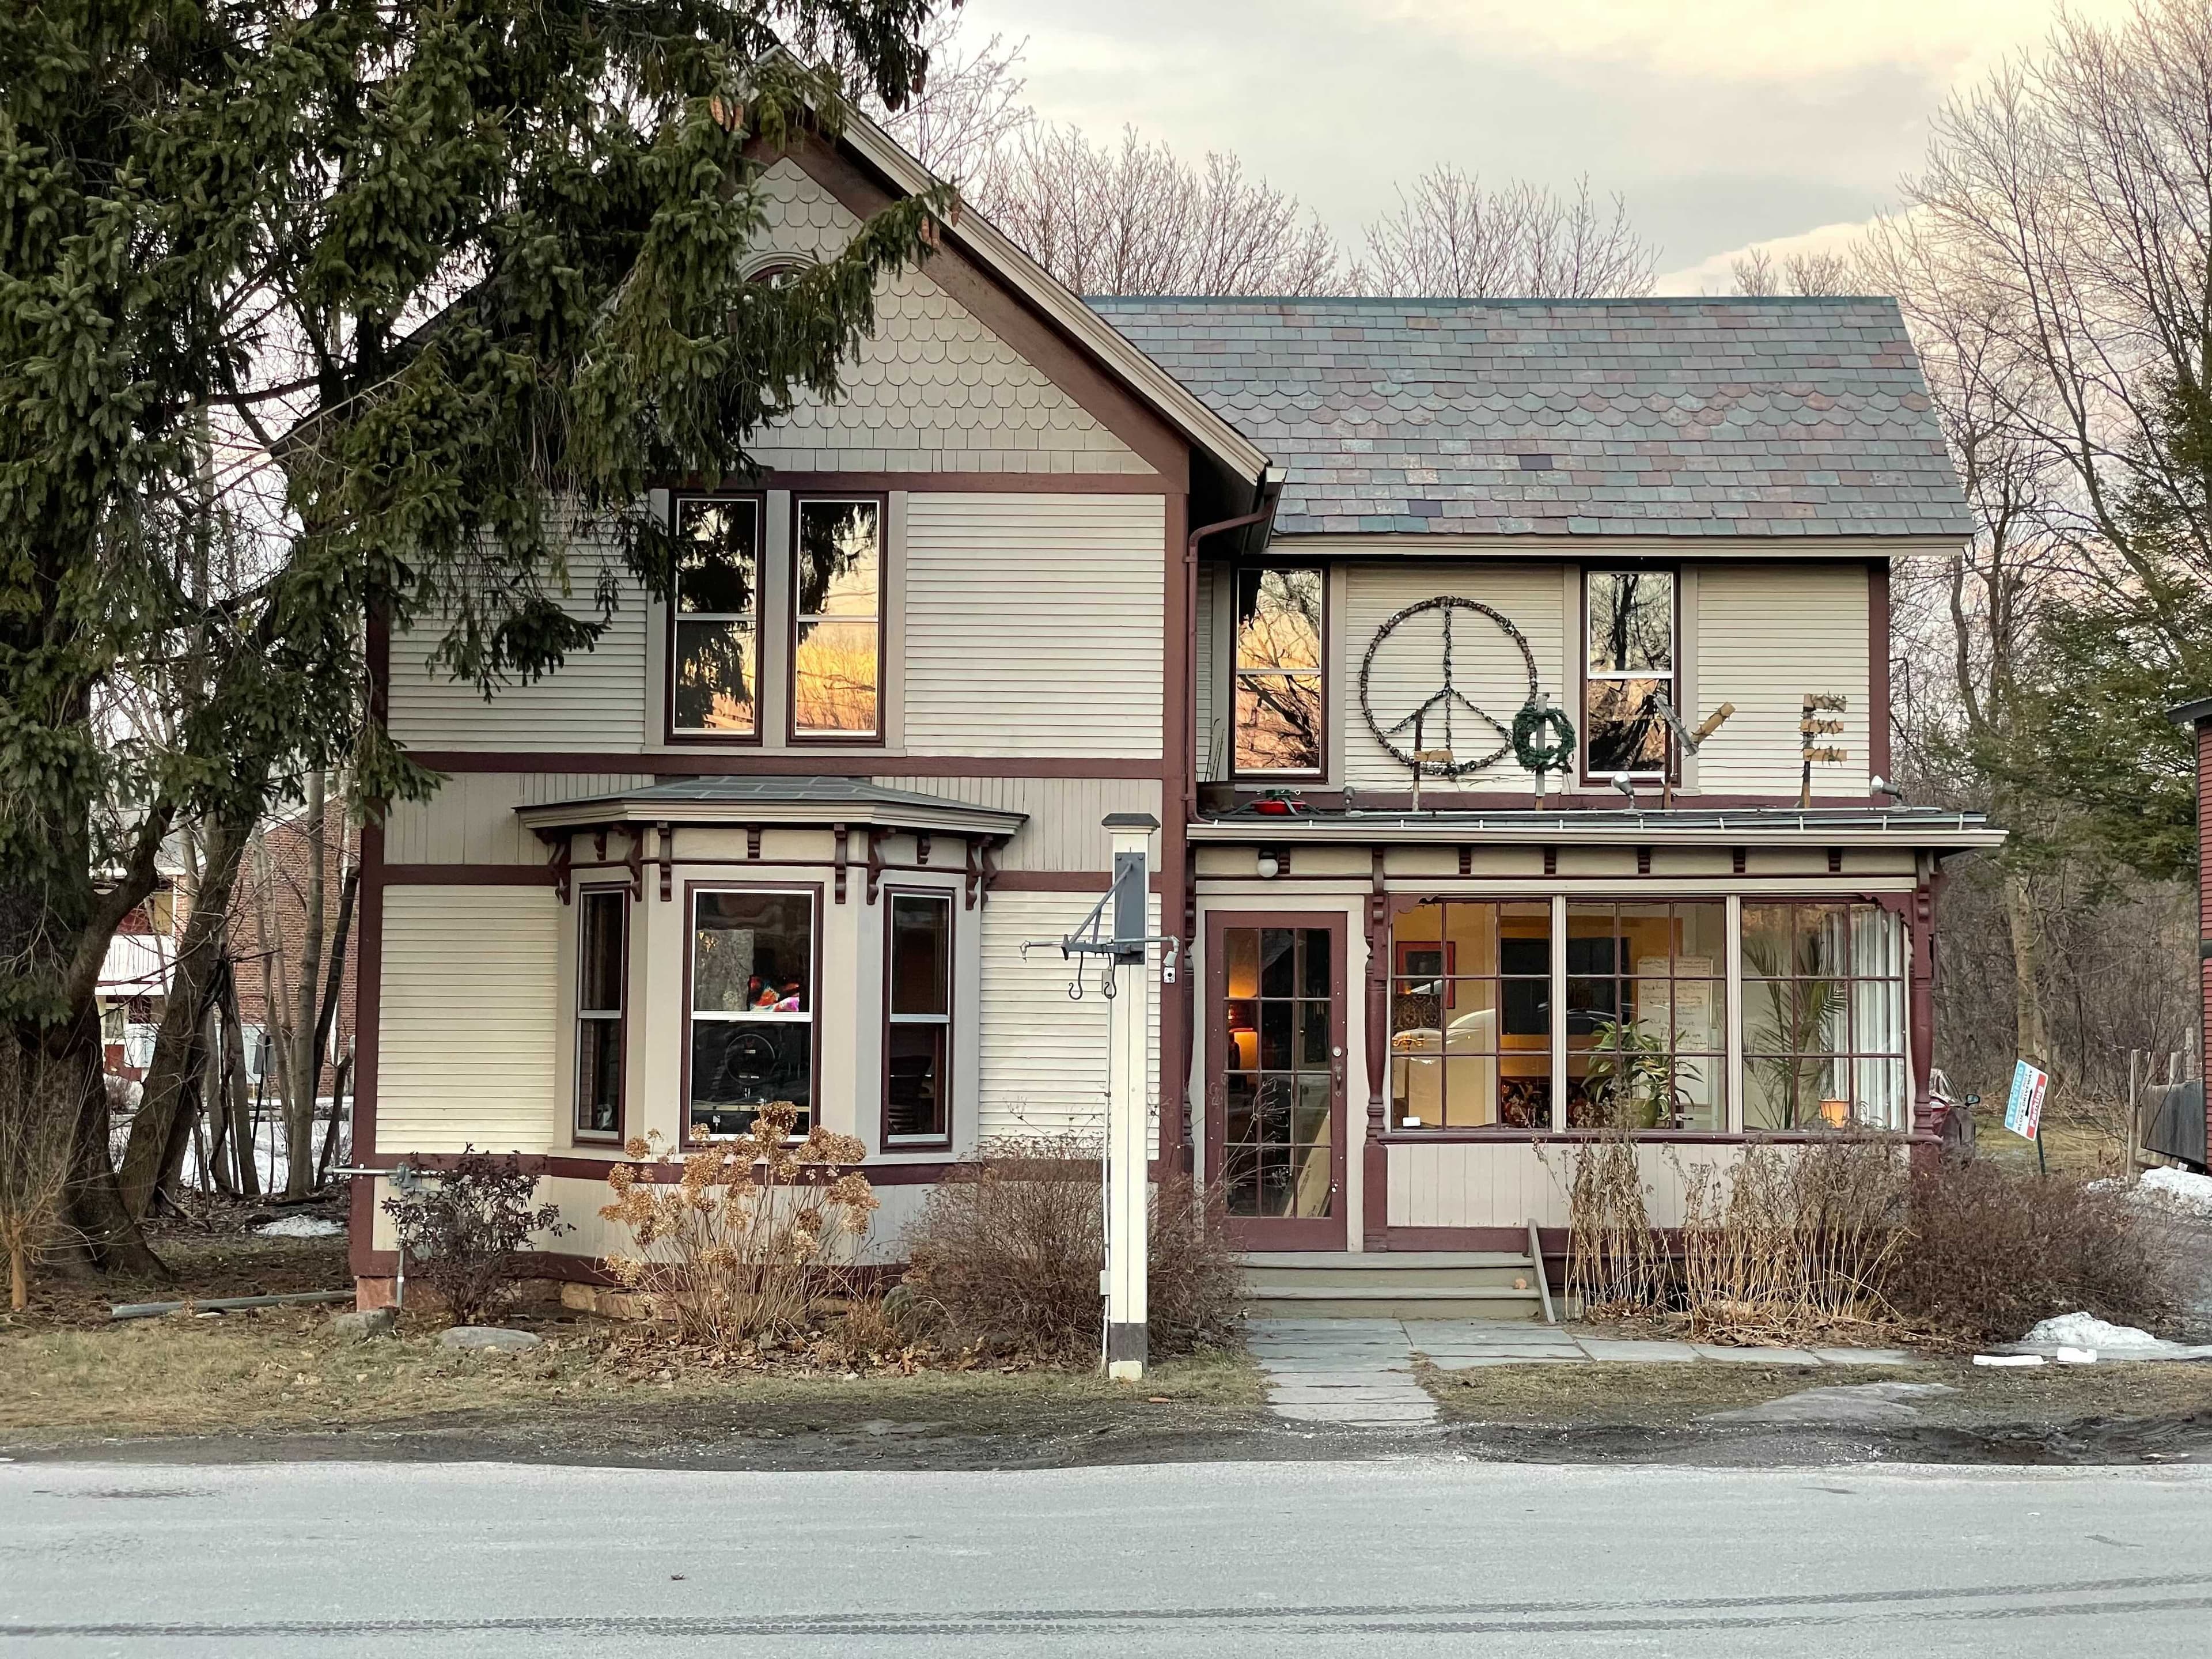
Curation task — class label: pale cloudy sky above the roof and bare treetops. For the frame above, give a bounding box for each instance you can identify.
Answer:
[962,0,2128,294]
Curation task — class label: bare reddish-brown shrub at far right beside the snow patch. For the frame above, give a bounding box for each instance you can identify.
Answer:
[1893,1159,2186,1345]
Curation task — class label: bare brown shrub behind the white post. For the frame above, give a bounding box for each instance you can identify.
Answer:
[907,1137,1237,1362]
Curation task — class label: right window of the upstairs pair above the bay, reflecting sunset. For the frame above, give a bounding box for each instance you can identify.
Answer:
[792,498,882,739]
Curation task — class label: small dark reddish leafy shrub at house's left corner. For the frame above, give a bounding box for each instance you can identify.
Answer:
[385,1146,573,1325]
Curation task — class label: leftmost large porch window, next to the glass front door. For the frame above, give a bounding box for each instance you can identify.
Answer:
[1389,898,1551,1128]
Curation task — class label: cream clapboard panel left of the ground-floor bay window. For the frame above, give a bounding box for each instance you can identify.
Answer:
[376,887,566,1153]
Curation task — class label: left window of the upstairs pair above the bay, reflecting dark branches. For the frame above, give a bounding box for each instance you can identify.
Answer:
[671,500,761,737]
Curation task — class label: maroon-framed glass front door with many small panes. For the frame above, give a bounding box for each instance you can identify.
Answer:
[1206,916,1345,1250]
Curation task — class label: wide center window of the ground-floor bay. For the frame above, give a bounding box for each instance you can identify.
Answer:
[690,887,814,1137]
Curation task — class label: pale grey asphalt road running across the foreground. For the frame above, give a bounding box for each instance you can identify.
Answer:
[0,1460,2212,1659]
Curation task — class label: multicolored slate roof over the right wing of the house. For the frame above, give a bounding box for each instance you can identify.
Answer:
[1090,297,1971,537]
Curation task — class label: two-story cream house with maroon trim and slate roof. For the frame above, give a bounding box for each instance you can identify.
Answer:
[354,100,1998,1294]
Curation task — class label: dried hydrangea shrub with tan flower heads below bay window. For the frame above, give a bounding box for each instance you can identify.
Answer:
[600,1101,876,1349]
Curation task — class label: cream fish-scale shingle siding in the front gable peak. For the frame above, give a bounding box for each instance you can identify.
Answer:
[750,159,1153,474]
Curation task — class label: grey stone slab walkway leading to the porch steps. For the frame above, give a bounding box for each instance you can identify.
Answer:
[1245,1319,1914,1427]
